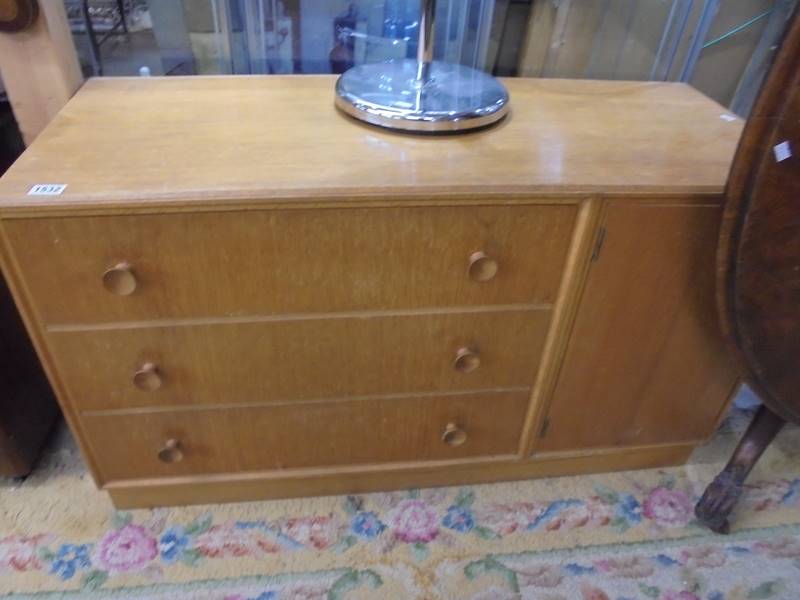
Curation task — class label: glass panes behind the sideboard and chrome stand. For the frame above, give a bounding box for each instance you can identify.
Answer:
[64,0,798,115]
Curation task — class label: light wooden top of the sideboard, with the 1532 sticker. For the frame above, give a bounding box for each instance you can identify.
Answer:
[0,75,742,216]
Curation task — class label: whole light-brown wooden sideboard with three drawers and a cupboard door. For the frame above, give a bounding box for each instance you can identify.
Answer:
[0,76,742,507]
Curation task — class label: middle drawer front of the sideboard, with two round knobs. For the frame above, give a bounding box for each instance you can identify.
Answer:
[50,310,550,410]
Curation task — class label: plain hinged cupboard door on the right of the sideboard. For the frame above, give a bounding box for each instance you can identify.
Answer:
[536,201,736,452]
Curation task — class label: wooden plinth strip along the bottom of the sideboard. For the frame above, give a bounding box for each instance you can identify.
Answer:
[104,441,696,509]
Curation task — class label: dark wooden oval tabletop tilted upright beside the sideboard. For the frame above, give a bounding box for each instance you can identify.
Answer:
[718,11,800,422]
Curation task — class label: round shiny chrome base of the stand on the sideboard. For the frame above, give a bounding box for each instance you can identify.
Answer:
[336,59,509,132]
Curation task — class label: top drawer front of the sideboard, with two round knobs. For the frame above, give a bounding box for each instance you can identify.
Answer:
[3,205,577,324]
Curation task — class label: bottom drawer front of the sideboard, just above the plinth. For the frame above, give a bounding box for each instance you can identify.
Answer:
[81,392,528,481]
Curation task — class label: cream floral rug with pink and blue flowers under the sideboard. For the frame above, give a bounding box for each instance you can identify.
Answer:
[0,400,800,600]
